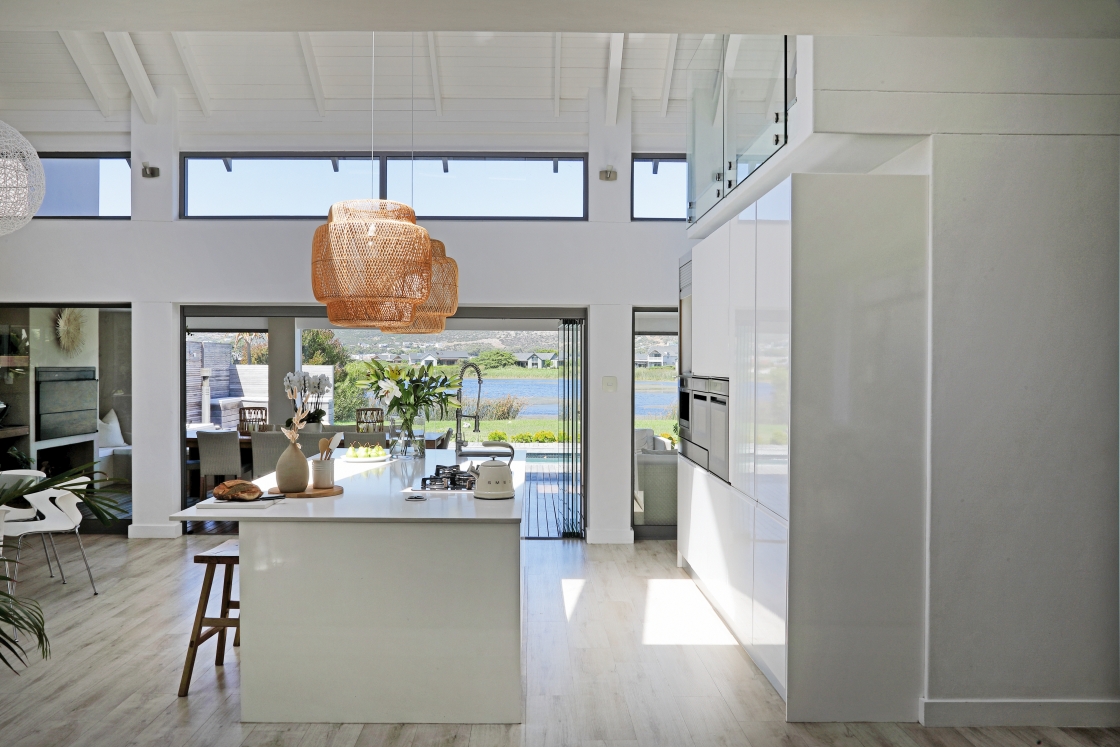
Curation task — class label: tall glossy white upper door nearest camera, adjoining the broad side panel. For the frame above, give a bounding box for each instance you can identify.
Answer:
[755,179,792,519]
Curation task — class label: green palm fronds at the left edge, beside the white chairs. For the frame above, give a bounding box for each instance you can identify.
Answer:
[0,463,130,673]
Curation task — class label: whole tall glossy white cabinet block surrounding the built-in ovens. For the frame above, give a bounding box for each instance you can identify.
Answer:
[678,175,928,721]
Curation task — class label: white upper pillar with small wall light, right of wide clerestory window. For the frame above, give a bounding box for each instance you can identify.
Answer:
[587,88,632,223]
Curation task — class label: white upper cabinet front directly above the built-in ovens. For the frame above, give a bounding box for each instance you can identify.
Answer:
[692,219,731,377]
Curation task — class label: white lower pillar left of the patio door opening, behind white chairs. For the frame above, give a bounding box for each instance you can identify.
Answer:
[129,302,183,539]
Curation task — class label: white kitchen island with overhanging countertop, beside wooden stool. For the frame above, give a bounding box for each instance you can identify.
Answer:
[171,450,524,723]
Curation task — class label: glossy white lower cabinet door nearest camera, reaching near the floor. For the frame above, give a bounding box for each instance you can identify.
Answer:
[752,508,790,698]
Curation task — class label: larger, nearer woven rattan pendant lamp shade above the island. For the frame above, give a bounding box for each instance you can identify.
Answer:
[311,199,432,327]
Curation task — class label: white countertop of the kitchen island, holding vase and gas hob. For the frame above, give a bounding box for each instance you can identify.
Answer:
[170,449,525,524]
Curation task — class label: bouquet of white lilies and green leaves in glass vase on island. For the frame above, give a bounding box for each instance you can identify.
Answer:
[360,361,461,459]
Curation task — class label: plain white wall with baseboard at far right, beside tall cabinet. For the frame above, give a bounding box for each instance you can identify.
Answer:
[924,136,1120,725]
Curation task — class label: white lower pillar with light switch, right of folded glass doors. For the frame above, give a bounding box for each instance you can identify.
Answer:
[586,304,634,543]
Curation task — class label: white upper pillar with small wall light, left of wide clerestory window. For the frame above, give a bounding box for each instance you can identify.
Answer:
[132,86,179,221]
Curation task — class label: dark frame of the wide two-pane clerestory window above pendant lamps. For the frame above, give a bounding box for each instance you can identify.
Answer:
[179,150,591,222]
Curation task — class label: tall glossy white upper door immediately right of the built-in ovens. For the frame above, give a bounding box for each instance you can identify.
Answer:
[728,205,756,497]
